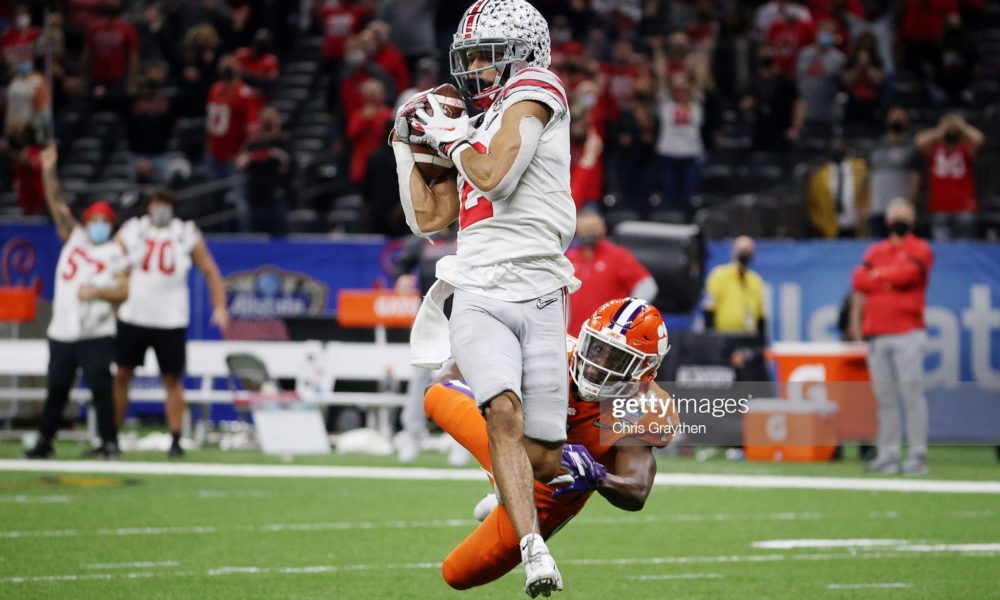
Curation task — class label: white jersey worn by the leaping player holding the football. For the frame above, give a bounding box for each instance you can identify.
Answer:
[437,67,580,302]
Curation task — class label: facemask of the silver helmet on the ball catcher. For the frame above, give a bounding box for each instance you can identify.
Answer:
[450,36,530,112]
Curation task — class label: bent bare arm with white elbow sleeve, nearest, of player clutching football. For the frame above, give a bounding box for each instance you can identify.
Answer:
[451,100,552,202]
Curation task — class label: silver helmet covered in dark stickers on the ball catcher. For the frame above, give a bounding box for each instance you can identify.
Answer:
[450,0,552,110]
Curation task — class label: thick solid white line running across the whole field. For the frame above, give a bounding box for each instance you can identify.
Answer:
[0,460,1000,494]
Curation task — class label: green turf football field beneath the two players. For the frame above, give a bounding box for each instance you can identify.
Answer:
[0,443,1000,599]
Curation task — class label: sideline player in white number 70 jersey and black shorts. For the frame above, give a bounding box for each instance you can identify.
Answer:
[114,189,229,458]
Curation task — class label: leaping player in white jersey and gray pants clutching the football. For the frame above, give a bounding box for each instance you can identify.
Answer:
[393,0,579,597]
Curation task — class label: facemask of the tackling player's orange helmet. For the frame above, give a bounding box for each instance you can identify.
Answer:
[570,326,661,402]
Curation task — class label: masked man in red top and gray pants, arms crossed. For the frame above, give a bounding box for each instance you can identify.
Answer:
[852,200,934,475]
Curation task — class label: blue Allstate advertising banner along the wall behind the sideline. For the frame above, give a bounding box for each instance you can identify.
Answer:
[0,223,1000,439]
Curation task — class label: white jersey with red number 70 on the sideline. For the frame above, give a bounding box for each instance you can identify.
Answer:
[118,216,201,329]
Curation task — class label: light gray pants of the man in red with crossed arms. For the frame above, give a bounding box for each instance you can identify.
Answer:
[868,329,927,456]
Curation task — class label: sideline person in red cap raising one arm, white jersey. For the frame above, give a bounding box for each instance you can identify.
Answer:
[24,146,128,459]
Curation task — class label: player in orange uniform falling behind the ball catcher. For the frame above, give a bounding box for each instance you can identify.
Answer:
[424,298,679,595]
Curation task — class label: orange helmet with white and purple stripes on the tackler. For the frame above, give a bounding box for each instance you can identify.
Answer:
[570,298,670,401]
